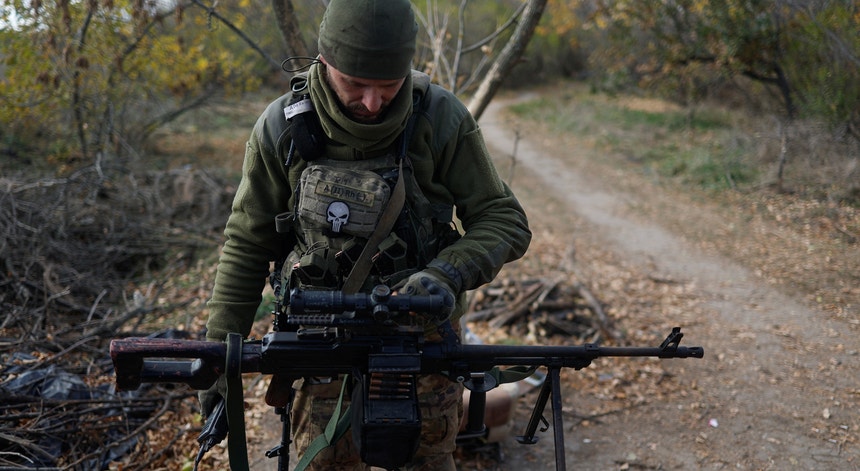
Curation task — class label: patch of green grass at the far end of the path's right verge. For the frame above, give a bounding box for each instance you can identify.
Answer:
[511,86,760,190]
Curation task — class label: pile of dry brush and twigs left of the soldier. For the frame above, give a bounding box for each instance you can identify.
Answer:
[0,166,231,469]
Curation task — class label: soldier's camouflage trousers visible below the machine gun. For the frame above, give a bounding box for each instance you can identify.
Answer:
[291,375,463,471]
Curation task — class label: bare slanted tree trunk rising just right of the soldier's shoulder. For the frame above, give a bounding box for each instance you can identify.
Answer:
[468,0,547,119]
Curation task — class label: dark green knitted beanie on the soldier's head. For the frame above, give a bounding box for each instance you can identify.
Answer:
[319,0,418,80]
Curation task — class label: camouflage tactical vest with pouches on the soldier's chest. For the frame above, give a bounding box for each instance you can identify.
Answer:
[271,77,460,309]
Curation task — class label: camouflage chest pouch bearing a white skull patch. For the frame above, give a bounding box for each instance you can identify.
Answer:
[298,164,391,239]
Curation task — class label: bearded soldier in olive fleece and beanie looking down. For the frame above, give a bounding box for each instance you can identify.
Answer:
[200,0,531,471]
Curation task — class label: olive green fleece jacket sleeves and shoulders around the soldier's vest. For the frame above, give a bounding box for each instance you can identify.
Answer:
[206,69,531,340]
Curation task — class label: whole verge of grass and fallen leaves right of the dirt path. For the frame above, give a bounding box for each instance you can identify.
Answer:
[509,84,860,317]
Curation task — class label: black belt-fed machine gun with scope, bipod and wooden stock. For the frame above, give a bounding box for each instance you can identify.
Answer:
[110,285,704,470]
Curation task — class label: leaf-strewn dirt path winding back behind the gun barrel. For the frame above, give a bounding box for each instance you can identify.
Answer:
[481,97,860,470]
